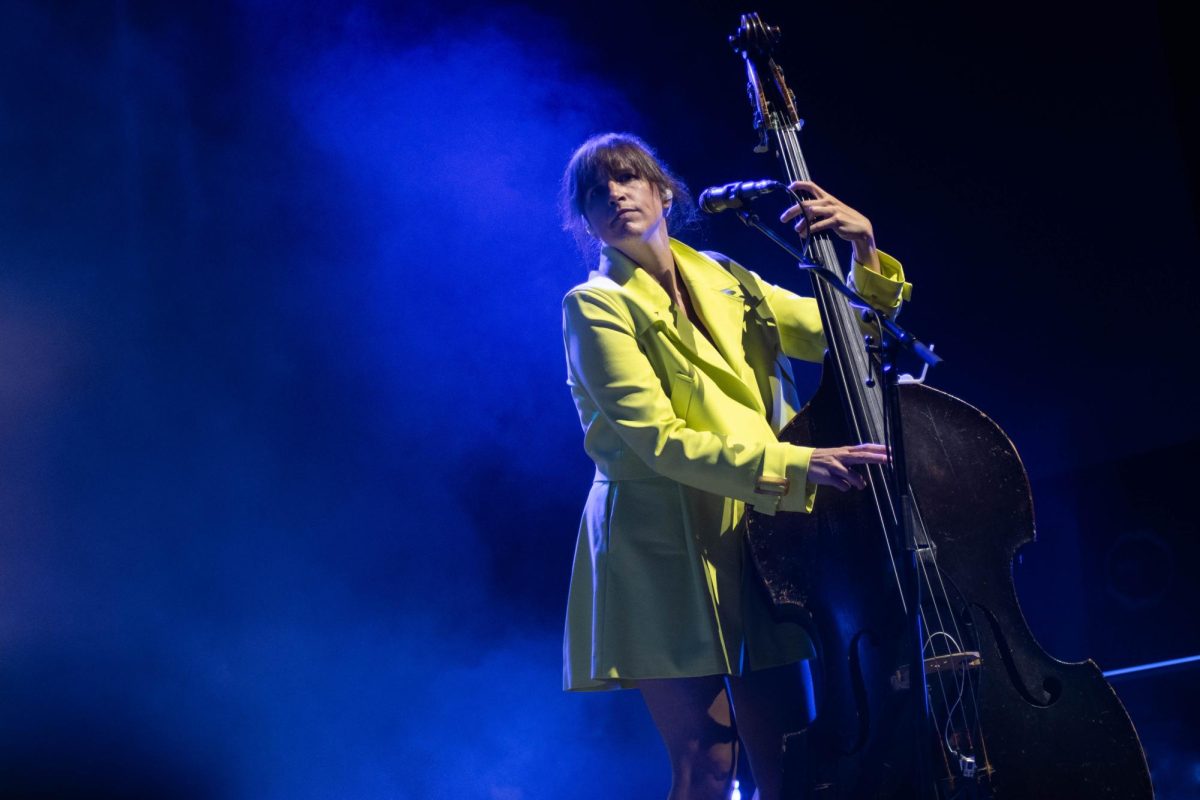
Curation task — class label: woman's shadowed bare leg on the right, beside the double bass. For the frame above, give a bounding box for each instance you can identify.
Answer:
[728,661,814,800]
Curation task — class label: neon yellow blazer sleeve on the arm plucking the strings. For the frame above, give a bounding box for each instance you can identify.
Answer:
[563,288,816,513]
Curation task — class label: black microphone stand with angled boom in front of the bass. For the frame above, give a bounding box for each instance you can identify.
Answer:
[737,209,942,800]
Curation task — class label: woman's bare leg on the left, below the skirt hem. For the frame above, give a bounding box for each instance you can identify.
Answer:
[637,675,734,800]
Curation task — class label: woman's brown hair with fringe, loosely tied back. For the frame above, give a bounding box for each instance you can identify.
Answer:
[558,133,696,255]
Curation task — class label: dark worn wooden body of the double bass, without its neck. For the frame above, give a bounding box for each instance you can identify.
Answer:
[748,367,1153,800]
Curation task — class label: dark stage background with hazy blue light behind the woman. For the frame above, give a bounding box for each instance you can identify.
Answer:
[0,0,1200,800]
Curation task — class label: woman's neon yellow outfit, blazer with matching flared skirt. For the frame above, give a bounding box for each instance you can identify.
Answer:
[563,240,910,690]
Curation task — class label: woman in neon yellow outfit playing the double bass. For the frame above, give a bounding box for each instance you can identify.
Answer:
[562,133,908,800]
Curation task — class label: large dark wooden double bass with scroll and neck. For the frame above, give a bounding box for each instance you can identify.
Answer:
[730,13,1153,800]
